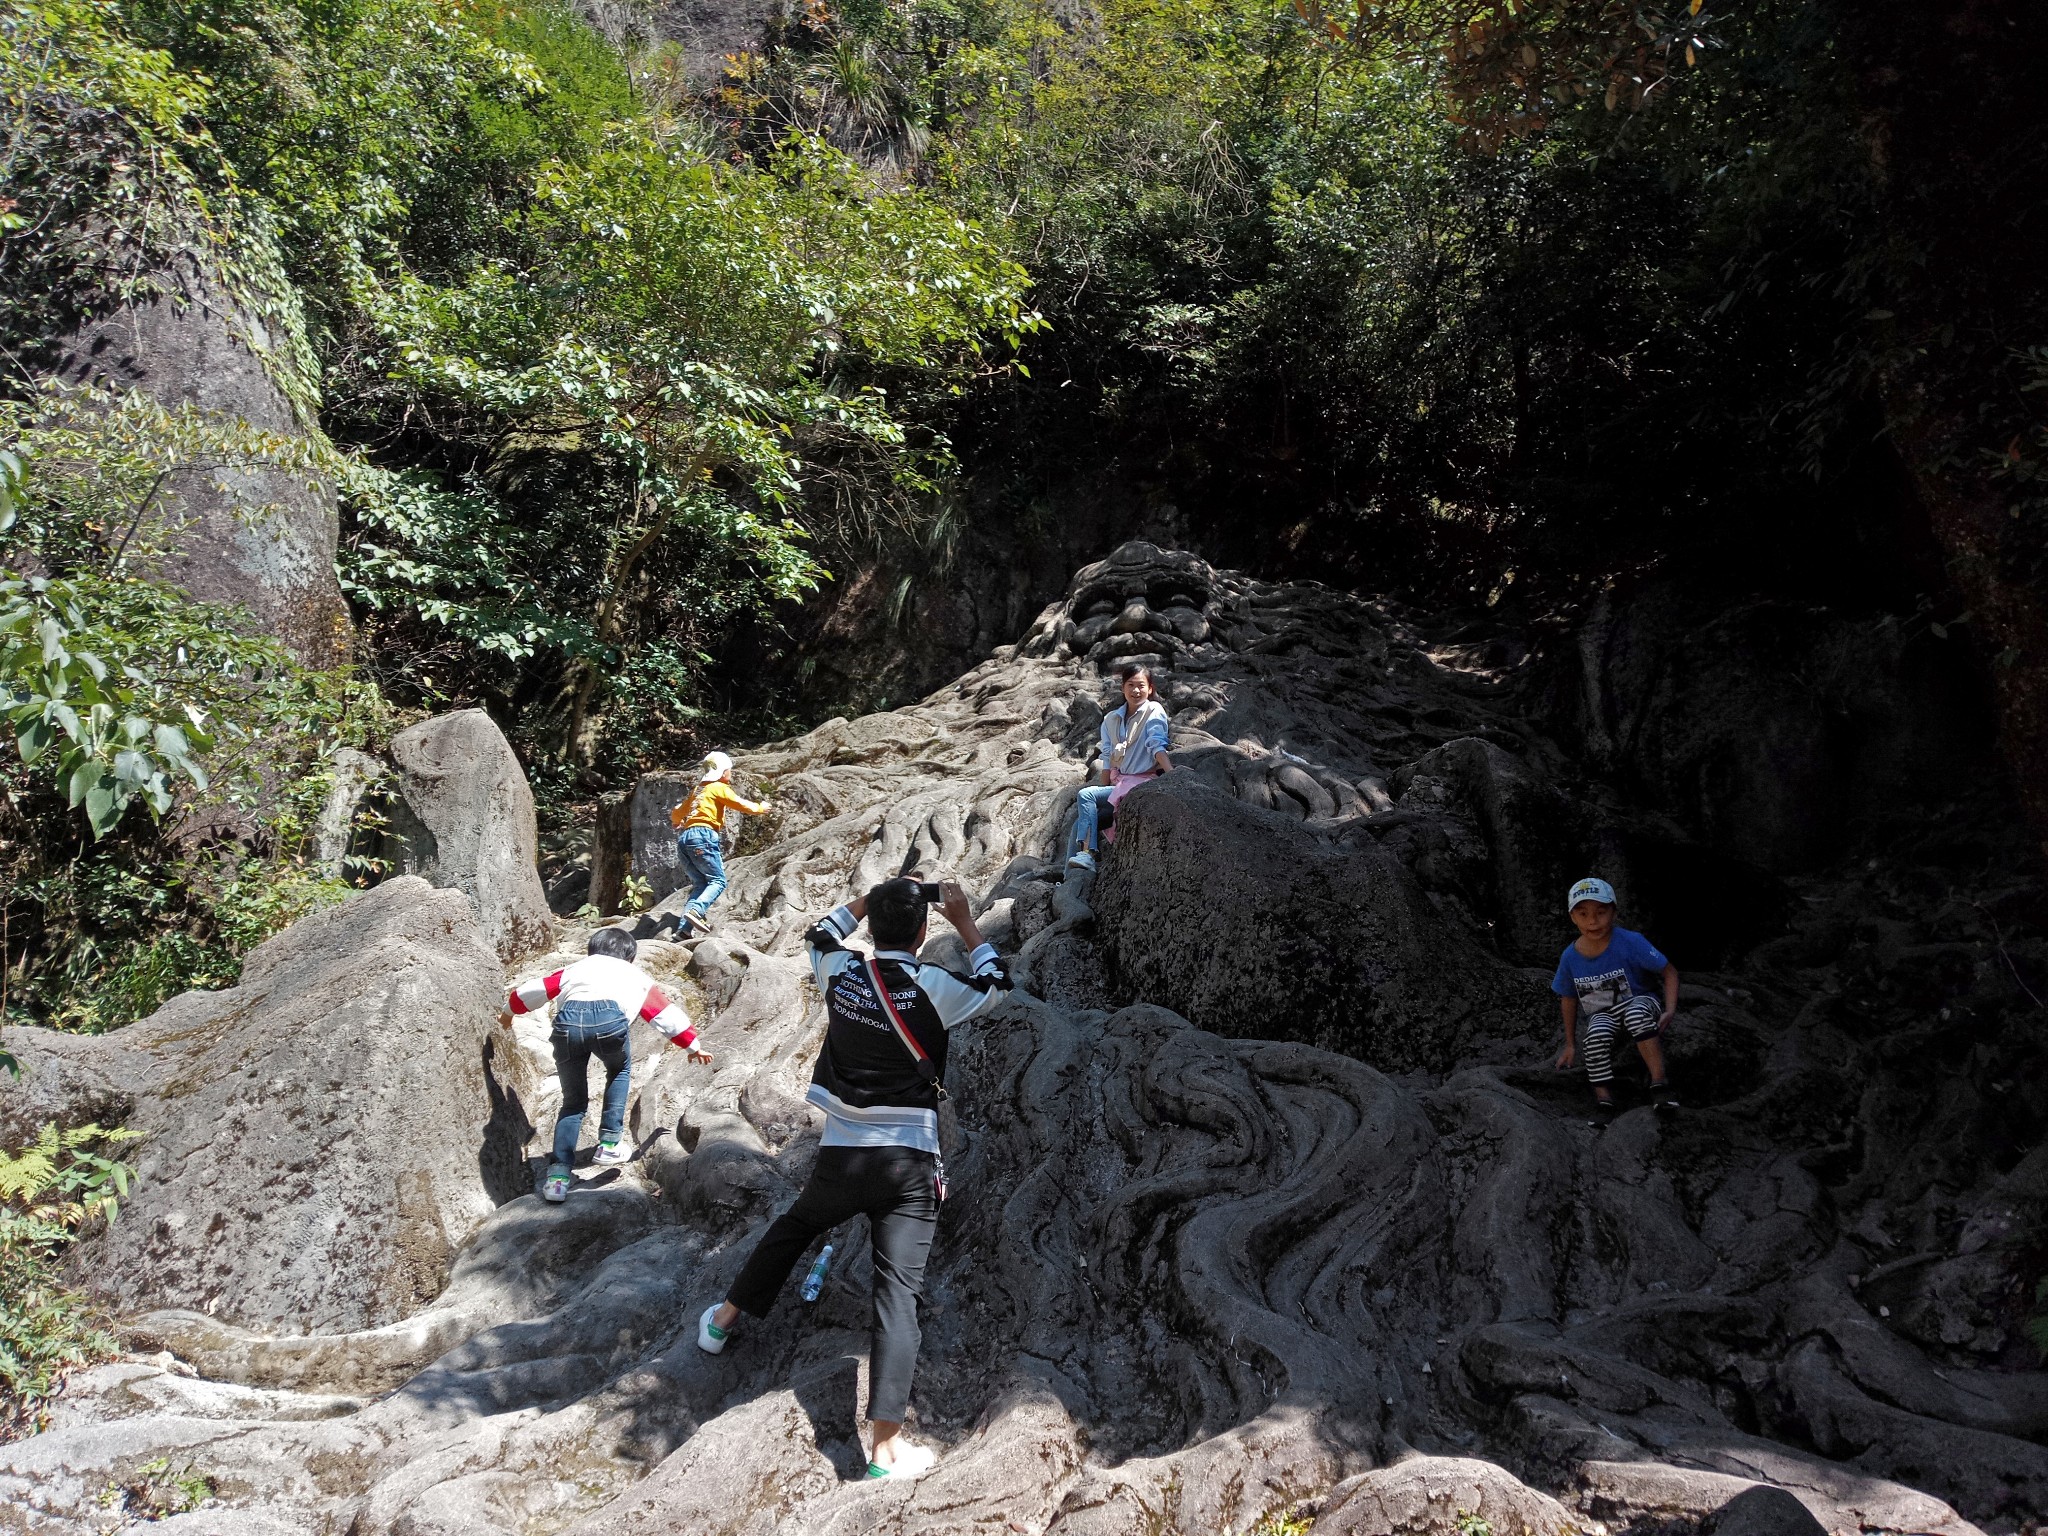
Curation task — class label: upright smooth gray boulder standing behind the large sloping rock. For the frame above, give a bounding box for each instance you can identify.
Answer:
[391,709,555,961]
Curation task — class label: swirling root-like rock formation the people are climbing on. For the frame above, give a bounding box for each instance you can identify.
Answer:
[0,547,2048,1536]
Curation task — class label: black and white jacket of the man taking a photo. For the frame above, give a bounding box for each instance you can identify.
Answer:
[803,907,1010,1153]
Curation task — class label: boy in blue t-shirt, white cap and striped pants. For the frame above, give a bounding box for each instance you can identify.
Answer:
[1550,879,1677,1126]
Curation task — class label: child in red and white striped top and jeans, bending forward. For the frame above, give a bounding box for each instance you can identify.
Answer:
[498,928,711,1204]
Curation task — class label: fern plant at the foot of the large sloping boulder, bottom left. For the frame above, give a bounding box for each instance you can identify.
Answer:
[0,1124,135,1440]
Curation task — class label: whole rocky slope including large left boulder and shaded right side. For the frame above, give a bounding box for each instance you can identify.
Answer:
[0,545,2048,1536]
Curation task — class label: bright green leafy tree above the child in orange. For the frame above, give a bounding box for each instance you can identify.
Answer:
[356,139,1034,754]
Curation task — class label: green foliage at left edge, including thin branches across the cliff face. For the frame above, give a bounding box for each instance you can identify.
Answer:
[0,370,383,1028]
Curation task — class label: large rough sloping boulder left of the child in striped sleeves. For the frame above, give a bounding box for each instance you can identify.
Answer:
[0,879,532,1333]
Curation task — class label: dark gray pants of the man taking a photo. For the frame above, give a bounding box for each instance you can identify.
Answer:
[725,1147,938,1423]
